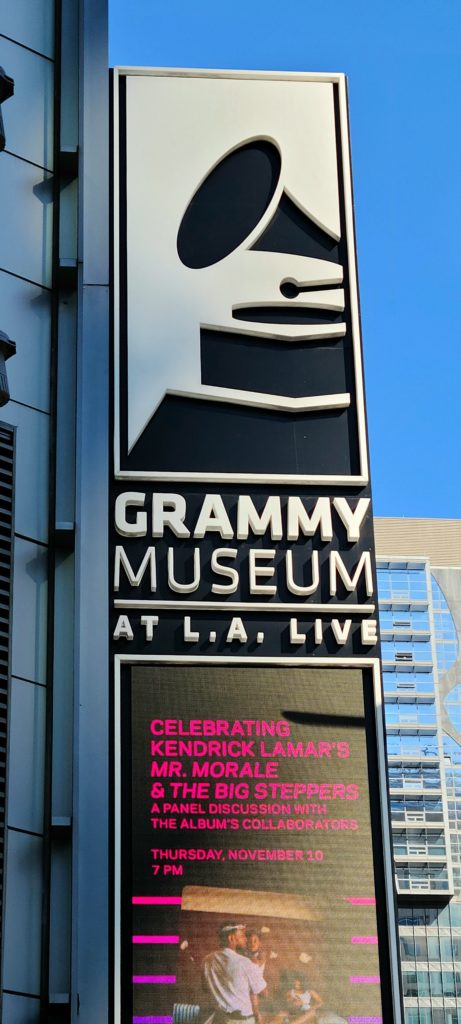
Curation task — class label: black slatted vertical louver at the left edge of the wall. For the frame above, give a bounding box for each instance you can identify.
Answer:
[0,423,14,949]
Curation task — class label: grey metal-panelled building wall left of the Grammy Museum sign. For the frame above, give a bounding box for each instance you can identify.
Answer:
[0,0,109,1024]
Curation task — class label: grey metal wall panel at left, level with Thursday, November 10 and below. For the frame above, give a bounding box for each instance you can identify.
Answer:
[3,829,43,995]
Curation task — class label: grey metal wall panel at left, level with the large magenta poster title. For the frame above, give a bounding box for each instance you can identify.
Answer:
[7,679,46,833]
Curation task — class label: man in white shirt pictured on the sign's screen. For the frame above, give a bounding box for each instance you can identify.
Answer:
[203,921,265,1024]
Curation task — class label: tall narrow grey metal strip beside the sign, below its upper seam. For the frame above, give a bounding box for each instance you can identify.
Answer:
[73,280,109,1024]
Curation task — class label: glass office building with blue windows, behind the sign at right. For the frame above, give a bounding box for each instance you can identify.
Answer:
[375,519,461,1024]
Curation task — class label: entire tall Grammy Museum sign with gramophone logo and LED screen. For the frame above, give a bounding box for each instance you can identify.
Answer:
[110,72,393,1024]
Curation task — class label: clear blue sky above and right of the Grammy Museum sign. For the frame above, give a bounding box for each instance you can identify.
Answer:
[110,0,461,518]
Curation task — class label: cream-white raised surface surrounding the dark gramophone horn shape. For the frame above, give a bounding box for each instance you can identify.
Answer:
[122,76,350,450]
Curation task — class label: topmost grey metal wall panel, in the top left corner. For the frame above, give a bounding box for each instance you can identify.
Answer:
[1,0,54,57]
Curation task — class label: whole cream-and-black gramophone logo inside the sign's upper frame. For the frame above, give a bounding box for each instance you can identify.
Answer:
[117,76,362,479]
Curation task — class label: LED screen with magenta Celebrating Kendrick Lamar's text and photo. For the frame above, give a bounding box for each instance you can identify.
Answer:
[118,664,385,1024]
